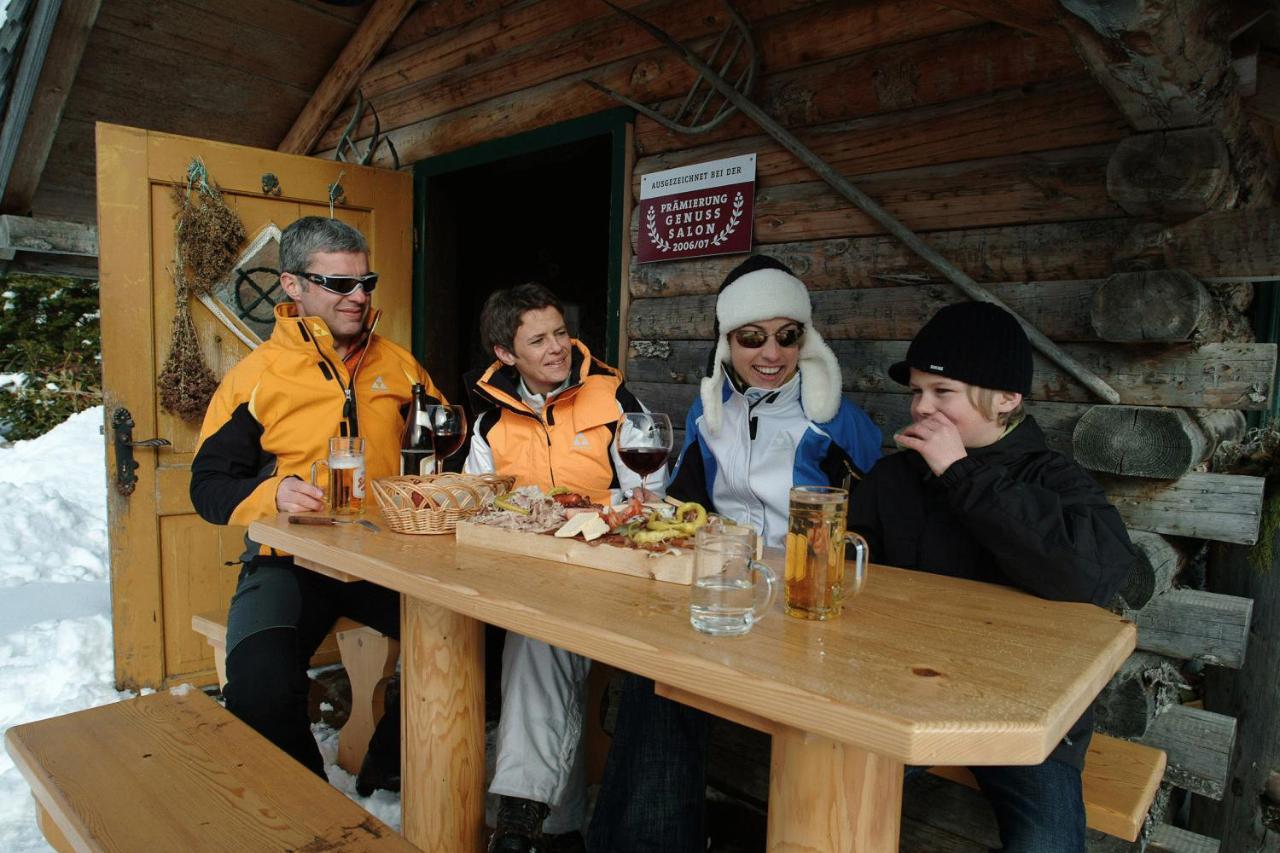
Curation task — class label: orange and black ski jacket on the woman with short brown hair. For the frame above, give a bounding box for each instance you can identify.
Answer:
[472,339,641,503]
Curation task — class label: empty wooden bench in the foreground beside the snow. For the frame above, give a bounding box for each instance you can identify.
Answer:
[5,688,416,853]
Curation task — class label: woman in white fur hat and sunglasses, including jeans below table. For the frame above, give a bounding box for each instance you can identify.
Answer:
[588,255,881,853]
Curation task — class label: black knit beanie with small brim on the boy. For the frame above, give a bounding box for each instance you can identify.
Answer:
[888,302,1032,394]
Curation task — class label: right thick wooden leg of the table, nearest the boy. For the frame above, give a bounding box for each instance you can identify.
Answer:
[768,729,902,853]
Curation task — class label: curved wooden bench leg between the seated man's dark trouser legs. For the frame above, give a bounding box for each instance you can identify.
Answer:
[338,628,399,776]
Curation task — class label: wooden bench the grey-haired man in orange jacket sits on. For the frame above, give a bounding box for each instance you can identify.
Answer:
[191,611,399,776]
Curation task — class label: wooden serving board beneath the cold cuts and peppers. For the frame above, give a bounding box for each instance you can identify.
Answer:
[457,520,694,587]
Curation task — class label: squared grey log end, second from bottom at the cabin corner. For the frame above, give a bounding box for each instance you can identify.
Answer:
[1140,704,1235,799]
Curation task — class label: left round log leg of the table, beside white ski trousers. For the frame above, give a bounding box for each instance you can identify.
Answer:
[401,596,485,853]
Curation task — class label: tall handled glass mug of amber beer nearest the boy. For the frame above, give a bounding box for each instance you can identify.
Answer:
[783,485,870,621]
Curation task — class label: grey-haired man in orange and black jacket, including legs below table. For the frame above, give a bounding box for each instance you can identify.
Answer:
[191,216,443,795]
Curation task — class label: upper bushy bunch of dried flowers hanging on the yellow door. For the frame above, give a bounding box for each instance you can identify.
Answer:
[173,158,246,293]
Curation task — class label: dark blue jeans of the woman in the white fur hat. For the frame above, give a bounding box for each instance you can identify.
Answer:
[586,674,710,853]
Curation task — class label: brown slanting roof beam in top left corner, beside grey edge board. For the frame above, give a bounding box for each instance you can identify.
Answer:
[0,0,101,214]
